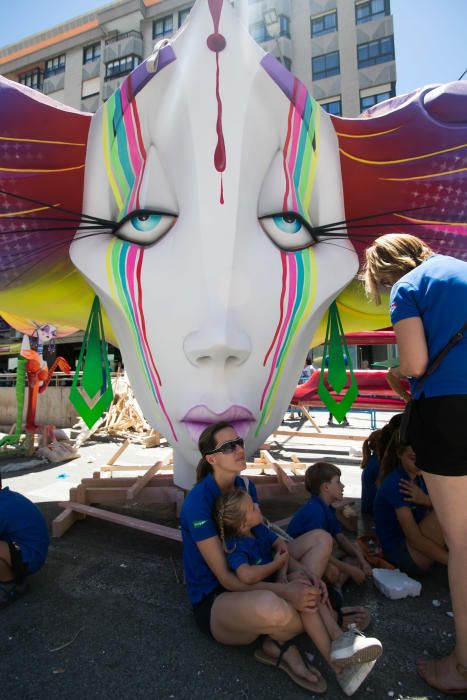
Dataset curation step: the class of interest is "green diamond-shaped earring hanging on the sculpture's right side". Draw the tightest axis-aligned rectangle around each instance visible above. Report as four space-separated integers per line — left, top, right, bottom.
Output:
318 301 358 423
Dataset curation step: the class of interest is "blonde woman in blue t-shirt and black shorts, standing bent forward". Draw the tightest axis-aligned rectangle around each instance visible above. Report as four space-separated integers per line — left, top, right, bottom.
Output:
364 233 467 696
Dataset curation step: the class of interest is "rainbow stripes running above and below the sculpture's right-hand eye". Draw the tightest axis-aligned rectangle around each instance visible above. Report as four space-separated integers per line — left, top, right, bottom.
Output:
256 59 320 435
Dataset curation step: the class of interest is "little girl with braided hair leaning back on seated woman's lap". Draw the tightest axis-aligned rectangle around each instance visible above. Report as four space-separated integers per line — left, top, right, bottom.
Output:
214 489 382 695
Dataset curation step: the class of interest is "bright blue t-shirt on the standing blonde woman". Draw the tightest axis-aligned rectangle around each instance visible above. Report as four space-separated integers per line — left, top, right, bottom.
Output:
390 255 467 398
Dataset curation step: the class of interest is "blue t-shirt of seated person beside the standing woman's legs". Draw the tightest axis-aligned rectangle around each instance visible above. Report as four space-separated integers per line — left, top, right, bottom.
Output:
373 466 428 559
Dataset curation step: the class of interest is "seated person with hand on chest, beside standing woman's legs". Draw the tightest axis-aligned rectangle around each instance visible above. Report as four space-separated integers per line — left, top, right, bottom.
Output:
374 431 448 578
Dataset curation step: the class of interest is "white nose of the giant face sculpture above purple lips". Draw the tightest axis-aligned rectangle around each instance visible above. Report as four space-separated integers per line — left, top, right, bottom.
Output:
183 319 251 367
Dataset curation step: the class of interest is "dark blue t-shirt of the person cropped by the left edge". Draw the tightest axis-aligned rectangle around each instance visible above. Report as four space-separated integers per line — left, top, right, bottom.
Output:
0 486 49 574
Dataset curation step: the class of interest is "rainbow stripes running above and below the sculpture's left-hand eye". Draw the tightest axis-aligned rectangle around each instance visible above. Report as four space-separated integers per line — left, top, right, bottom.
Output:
102 72 177 440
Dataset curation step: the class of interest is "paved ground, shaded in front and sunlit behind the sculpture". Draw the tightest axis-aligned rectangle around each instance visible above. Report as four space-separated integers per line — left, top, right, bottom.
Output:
0 414 453 700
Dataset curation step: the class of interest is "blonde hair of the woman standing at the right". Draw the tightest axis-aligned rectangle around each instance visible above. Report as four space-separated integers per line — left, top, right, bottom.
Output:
361 233 433 304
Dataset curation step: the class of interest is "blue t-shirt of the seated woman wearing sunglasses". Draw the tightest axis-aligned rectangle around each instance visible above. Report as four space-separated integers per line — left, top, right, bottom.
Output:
180 474 258 604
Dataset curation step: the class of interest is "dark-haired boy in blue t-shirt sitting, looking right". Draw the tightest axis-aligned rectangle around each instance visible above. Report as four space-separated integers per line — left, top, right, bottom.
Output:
287 462 372 592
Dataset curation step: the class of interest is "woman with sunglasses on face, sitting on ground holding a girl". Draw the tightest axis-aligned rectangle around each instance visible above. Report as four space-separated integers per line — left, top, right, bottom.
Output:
181 422 380 692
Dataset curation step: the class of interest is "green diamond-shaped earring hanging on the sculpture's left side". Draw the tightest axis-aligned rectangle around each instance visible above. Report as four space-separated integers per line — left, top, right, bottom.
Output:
70 296 113 428
